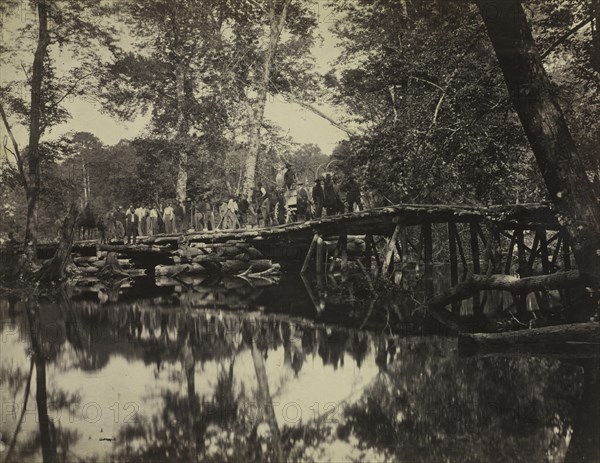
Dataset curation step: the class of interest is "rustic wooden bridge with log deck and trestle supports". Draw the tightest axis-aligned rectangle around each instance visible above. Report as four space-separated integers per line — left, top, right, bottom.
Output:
32 199 571 284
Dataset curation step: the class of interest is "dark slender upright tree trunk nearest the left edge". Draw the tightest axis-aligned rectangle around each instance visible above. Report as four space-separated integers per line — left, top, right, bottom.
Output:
25 0 50 256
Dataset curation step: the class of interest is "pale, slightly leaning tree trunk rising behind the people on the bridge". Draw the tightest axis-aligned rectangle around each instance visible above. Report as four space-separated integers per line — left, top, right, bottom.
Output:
244 0 291 200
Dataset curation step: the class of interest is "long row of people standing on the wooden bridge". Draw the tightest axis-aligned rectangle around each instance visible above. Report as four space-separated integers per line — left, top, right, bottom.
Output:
78 169 362 244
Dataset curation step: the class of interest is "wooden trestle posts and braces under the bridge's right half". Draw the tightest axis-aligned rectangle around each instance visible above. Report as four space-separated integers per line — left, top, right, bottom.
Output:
301 221 571 312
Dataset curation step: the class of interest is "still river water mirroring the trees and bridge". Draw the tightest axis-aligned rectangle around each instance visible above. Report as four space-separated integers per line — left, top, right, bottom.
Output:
0 272 600 463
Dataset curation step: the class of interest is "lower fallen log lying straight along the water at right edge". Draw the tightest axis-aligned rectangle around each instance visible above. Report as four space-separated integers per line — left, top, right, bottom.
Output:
458 322 600 351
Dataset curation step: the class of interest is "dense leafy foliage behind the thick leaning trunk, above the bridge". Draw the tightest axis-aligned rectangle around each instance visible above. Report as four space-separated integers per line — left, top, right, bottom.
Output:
326 0 598 204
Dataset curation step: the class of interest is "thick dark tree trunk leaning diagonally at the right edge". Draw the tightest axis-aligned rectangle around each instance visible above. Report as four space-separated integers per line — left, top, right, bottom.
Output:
477 0 600 278
